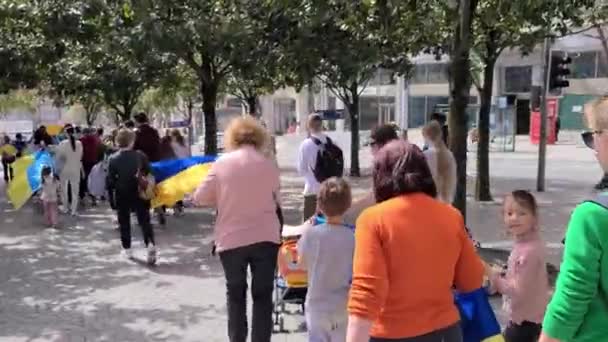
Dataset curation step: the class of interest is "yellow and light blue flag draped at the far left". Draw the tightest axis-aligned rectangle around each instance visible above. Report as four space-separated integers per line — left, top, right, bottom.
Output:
6 150 54 209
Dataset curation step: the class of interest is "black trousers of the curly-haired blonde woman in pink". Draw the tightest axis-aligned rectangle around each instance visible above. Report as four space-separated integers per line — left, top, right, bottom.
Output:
220 242 279 342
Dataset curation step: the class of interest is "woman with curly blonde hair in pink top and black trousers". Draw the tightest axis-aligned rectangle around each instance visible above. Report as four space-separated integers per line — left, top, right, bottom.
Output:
192 117 280 342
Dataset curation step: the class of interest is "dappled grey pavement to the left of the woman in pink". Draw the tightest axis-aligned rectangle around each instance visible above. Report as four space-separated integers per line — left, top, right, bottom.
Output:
0 198 225 341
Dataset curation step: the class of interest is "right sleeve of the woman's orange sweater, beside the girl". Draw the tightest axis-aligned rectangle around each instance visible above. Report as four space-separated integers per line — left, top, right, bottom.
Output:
454 214 485 292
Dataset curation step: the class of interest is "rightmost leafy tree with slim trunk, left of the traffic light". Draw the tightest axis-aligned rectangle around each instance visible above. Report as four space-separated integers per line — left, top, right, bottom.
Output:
473 0 594 201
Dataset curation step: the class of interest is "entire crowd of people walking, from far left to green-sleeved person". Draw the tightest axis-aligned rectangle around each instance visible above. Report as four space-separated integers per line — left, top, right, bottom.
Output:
2 99 608 342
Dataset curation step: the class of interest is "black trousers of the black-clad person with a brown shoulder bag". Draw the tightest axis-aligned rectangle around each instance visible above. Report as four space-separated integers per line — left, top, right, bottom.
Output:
116 193 155 249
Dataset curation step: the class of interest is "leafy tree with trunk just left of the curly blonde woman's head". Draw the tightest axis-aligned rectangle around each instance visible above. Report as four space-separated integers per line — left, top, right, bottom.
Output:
132 0 280 154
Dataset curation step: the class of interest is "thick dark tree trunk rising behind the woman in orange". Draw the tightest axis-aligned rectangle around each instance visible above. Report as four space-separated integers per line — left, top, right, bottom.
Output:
448 0 477 222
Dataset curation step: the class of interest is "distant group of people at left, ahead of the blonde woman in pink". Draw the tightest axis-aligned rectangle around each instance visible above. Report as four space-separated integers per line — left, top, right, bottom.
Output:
0 113 190 263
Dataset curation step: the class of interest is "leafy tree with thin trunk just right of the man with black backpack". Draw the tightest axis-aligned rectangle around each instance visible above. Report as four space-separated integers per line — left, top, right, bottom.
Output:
280 0 432 176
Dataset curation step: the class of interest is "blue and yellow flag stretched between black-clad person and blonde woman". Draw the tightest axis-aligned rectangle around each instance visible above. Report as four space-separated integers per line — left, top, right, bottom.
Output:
152 156 217 208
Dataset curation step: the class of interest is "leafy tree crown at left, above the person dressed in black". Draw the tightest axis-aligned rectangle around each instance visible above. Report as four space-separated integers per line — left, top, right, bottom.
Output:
48 0 175 122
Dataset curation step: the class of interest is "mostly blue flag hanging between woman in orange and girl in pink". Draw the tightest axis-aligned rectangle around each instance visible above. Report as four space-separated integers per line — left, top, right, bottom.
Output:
455 288 505 342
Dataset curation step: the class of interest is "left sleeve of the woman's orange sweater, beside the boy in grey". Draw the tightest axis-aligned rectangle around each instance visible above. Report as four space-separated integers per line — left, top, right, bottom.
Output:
348 213 388 321
